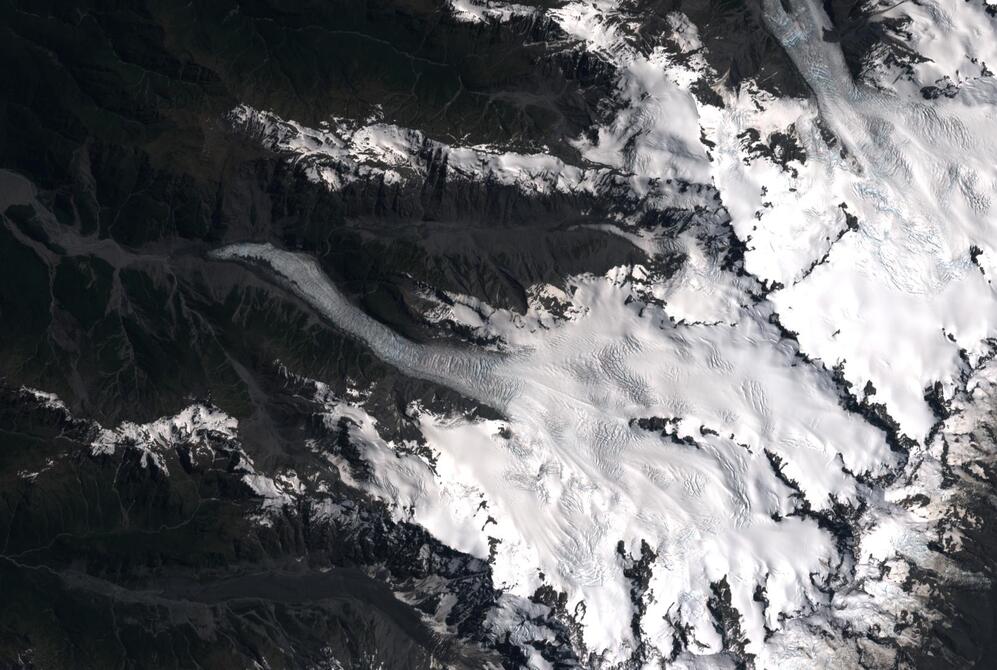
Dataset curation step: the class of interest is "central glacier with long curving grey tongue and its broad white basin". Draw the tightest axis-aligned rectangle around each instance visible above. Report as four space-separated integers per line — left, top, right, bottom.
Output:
212 239 896 661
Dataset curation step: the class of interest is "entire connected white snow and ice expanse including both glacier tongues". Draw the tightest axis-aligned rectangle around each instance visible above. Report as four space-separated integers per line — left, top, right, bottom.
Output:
206 0 997 668
